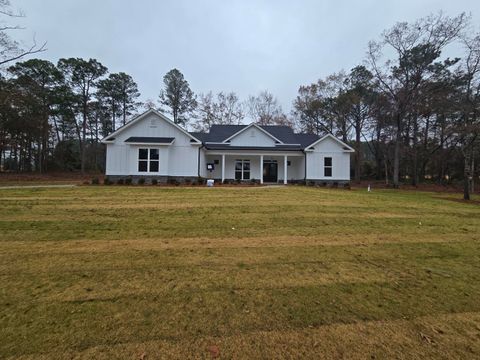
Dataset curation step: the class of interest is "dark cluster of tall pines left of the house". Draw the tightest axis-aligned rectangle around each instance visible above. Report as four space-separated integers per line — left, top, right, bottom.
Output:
0 58 140 173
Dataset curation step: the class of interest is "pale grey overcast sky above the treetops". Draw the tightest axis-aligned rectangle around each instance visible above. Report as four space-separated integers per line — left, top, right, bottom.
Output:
11 0 480 111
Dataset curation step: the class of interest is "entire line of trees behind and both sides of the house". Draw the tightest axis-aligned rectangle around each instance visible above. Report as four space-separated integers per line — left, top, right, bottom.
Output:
0 3 480 199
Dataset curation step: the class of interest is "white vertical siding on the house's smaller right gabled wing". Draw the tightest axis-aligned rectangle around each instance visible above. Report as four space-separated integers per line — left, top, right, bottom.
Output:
306 138 350 181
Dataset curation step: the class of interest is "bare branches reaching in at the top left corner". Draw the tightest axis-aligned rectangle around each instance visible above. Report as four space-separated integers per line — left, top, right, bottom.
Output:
0 0 46 66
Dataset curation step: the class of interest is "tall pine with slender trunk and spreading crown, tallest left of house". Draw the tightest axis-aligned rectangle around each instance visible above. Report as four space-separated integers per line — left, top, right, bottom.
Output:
58 58 107 174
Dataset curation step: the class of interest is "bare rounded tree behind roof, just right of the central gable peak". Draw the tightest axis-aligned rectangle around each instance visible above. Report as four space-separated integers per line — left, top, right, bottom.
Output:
247 90 286 125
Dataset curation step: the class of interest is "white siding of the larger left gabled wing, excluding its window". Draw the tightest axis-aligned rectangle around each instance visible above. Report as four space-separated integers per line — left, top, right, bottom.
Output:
106 113 199 176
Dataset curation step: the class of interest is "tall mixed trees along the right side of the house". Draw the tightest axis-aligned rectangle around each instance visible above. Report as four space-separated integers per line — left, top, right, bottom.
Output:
288 13 480 199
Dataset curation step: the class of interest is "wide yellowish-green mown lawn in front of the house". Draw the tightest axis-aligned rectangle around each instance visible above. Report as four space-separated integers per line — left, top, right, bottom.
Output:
0 186 480 359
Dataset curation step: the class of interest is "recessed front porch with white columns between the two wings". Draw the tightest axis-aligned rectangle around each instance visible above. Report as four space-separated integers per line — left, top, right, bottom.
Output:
206 152 305 184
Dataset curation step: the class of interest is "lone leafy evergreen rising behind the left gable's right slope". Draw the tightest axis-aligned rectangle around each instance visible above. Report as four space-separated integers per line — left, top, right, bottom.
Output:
160 69 197 125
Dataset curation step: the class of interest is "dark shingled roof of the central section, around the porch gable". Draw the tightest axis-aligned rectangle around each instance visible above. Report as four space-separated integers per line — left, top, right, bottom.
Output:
190 125 320 151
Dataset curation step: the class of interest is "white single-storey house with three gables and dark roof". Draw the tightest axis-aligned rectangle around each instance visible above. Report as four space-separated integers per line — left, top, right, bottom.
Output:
102 110 354 184
